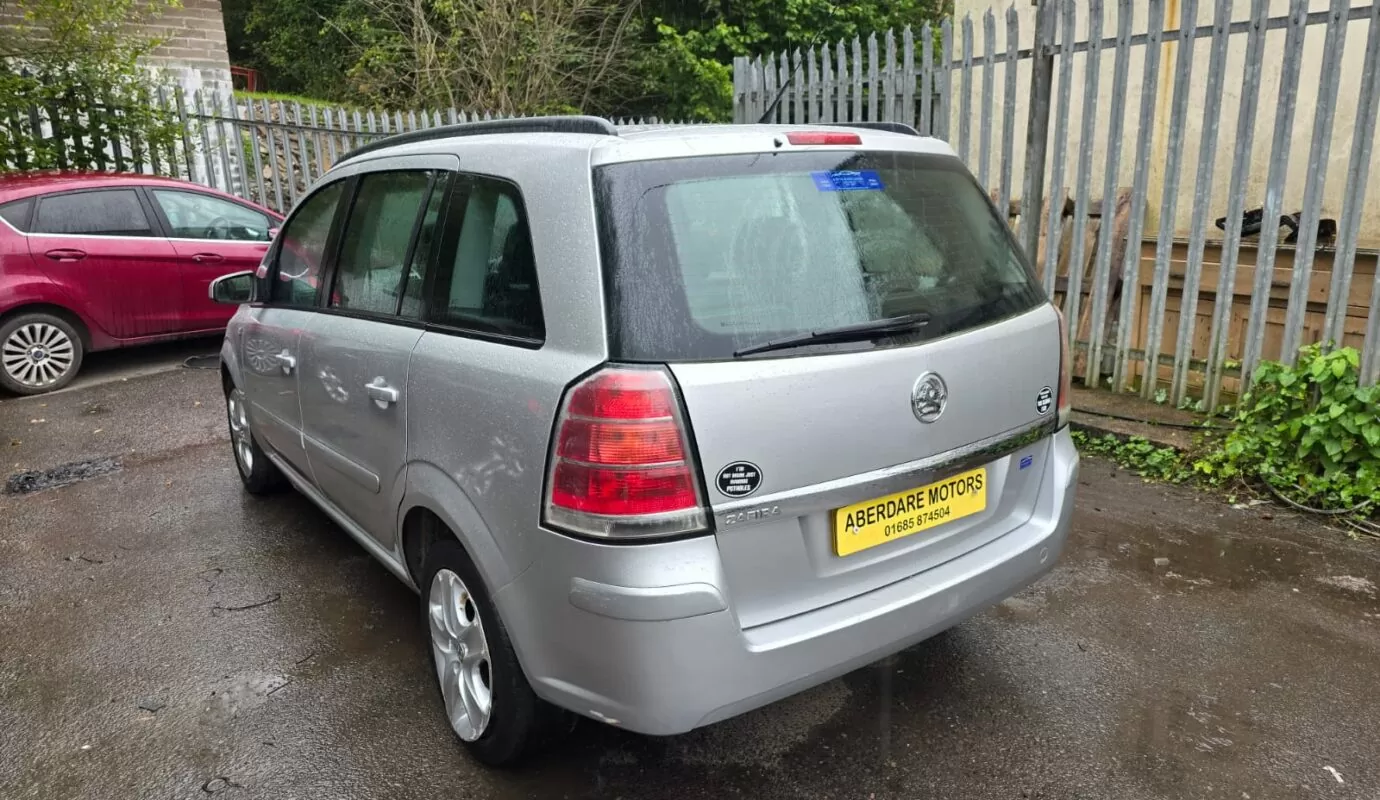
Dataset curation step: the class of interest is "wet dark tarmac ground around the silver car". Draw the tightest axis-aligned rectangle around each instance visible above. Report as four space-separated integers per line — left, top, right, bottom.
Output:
0 371 1380 800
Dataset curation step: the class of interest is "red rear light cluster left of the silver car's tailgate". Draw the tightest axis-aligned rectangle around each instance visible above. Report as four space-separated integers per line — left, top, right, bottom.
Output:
544 367 708 538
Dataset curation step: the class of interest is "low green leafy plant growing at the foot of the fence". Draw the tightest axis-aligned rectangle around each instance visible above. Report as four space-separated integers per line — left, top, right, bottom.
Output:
1194 345 1380 509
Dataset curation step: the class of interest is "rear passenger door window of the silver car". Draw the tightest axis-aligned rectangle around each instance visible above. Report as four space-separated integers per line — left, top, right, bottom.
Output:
330 171 432 314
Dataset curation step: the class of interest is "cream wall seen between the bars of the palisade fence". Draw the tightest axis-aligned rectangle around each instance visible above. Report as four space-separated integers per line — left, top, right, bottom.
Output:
951 0 1380 247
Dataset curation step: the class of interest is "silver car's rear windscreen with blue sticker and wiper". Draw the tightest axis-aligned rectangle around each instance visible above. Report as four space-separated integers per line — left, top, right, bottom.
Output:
595 150 1045 361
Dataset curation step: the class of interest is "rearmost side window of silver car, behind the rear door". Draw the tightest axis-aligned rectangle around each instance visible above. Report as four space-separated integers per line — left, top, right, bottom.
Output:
428 177 546 341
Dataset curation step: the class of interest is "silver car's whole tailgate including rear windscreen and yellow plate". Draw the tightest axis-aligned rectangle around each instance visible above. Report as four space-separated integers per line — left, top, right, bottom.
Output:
595 139 1060 626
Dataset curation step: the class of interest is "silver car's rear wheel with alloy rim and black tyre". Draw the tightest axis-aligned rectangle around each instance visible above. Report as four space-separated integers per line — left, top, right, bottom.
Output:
421 539 570 767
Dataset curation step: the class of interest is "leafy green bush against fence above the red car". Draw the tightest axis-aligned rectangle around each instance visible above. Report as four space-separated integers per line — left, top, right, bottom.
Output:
0 0 181 170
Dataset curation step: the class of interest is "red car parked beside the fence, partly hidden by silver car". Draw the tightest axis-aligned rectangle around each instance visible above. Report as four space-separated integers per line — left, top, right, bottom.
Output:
0 172 283 394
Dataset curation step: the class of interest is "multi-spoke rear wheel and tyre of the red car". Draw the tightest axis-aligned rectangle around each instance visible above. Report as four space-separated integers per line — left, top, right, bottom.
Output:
0 312 84 394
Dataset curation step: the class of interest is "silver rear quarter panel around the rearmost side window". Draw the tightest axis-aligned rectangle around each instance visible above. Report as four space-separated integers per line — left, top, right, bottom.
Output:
400 135 607 594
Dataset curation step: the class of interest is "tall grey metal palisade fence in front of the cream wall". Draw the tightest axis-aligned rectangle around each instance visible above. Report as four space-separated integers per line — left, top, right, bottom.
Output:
733 0 1380 397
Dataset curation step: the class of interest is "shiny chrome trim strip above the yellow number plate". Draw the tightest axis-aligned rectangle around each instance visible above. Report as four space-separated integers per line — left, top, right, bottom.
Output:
713 417 1058 532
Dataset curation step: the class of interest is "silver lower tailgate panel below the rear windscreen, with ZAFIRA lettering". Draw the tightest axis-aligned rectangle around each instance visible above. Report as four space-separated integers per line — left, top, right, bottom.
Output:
672 306 1060 628
